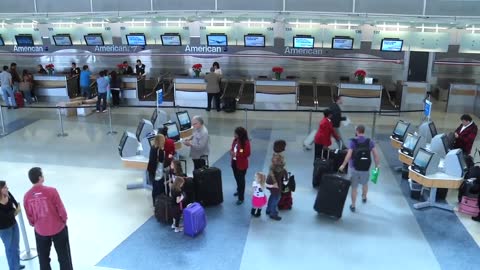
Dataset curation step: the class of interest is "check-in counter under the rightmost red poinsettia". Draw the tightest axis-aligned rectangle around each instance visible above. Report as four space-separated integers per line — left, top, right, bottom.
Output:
338 83 383 111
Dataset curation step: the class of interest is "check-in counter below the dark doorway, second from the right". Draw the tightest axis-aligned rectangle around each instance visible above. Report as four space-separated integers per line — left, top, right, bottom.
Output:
401 82 429 111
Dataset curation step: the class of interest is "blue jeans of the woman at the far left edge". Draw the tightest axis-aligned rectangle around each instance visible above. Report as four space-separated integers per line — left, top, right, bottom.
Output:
0 223 20 270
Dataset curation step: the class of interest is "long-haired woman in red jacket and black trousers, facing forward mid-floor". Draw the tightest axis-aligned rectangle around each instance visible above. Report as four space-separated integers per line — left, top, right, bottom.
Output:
230 127 250 205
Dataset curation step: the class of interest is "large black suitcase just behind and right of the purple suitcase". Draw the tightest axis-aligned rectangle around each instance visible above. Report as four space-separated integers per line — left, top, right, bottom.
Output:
193 167 223 206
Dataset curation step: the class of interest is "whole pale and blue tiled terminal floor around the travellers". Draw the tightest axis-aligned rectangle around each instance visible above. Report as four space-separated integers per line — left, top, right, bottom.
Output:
0 102 480 270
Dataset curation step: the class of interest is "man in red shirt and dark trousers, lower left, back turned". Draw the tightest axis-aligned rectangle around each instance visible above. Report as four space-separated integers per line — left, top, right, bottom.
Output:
23 167 73 270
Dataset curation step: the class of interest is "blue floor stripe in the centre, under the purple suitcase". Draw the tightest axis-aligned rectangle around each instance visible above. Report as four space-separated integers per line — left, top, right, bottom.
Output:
98 129 271 270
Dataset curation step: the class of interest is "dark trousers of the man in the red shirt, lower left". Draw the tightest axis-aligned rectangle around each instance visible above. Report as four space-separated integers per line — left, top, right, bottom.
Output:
35 226 73 270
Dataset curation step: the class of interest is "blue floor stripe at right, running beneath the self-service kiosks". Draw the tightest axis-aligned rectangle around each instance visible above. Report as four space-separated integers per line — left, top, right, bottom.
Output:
377 136 480 270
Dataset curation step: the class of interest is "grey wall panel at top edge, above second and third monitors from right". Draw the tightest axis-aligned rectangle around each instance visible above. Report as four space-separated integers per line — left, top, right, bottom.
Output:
279 0 353 12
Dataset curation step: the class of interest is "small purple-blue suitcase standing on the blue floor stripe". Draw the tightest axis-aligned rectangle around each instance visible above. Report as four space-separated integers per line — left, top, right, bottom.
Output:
183 203 207 237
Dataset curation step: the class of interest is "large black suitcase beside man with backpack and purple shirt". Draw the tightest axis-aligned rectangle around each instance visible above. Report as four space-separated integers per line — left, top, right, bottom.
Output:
313 174 350 218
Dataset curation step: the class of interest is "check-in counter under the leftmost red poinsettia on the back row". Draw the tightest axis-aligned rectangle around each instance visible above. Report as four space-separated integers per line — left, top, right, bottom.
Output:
173 78 207 108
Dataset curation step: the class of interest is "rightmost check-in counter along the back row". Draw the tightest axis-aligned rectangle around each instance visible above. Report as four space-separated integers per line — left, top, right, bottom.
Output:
447 83 478 113
